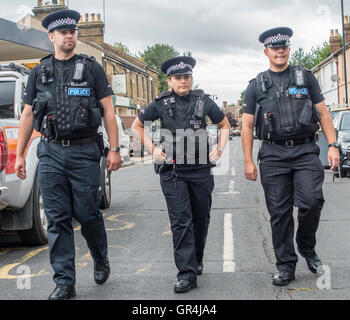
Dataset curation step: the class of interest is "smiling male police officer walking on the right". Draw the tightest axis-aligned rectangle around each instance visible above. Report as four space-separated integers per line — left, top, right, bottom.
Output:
242 28 339 286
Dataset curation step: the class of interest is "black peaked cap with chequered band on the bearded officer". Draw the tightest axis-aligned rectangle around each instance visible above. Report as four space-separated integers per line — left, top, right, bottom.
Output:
42 10 80 32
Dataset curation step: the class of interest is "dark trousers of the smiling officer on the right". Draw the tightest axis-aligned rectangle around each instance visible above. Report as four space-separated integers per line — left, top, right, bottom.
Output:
258 143 324 272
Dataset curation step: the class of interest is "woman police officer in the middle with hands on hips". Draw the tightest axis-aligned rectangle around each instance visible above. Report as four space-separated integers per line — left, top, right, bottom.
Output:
132 56 230 293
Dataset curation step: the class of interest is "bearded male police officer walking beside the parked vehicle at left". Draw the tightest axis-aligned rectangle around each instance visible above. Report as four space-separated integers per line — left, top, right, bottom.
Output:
16 10 121 300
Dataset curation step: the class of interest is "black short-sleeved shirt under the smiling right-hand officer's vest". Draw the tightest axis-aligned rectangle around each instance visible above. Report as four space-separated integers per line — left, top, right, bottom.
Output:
243 66 324 115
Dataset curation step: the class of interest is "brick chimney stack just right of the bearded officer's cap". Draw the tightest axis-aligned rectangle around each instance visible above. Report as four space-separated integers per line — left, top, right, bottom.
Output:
78 13 105 44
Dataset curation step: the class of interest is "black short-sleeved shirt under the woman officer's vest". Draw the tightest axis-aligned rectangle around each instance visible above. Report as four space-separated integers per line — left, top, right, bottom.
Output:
139 92 225 124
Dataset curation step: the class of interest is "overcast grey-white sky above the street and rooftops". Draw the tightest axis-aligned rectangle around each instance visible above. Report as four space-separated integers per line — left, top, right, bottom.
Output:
0 0 350 104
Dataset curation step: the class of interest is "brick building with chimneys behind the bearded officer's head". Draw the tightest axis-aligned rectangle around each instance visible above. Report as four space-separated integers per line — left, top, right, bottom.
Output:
19 0 159 115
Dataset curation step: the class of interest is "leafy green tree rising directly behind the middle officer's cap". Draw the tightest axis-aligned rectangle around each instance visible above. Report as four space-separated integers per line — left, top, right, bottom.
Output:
139 43 180 92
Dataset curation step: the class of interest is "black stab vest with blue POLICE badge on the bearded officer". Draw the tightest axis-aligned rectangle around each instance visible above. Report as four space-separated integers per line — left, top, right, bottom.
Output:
33 54 103 139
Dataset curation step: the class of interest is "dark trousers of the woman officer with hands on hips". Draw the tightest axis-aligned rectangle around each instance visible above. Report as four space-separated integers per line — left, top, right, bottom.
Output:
160 167 214 280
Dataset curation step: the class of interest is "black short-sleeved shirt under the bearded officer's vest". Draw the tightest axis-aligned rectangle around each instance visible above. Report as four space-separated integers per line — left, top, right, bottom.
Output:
23 56 114 106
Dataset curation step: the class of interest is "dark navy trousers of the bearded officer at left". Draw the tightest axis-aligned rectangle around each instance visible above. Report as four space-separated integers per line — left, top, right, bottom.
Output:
37 141 107 285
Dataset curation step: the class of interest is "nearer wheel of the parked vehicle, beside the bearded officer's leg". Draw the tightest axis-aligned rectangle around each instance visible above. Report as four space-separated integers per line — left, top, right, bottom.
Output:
18 174 47 245
